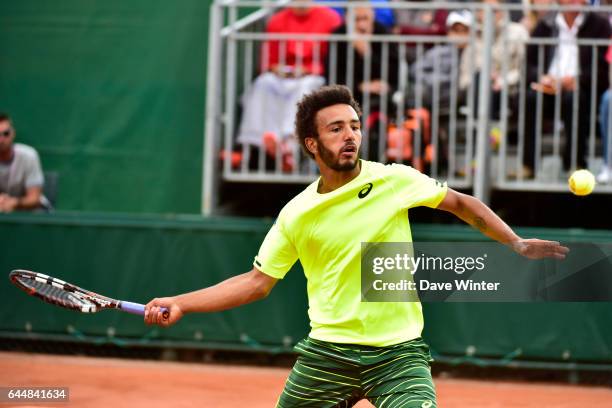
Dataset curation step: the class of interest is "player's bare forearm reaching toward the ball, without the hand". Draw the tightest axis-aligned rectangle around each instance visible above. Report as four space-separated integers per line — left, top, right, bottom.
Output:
454 194 520 244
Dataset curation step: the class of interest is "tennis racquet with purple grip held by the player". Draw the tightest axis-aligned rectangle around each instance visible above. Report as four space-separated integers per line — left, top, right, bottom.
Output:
9 269 170 319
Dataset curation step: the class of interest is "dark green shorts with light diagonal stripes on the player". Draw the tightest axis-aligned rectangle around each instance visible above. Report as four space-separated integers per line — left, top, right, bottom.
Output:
276 338 436 408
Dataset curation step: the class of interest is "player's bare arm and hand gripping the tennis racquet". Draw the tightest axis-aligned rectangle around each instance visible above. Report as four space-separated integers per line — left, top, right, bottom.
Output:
144 268 278 327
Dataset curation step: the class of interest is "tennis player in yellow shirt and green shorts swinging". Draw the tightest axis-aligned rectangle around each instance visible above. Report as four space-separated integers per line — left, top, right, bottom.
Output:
145 86 568 408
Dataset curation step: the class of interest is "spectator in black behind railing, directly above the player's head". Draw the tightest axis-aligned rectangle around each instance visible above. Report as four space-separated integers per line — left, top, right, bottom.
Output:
325 1 399 160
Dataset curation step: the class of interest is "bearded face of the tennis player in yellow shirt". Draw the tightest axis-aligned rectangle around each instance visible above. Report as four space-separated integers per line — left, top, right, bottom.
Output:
317 104 361 171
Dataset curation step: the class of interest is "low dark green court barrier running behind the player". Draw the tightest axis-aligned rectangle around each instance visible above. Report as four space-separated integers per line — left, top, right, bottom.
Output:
0 214 612 369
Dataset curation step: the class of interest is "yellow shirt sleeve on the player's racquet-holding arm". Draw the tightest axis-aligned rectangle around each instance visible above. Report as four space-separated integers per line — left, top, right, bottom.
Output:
253 217 298 279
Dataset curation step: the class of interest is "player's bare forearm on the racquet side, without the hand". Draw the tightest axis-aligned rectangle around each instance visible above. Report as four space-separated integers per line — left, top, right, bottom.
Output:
175 272 271 313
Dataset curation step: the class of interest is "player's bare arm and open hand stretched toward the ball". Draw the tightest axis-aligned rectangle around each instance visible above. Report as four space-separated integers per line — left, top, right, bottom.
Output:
438 188 569 259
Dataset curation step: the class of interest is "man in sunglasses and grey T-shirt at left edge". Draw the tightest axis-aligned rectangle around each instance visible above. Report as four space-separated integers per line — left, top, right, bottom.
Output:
0 113 46 213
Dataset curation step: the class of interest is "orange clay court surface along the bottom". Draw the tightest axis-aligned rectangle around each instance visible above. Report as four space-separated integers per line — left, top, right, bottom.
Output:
0 352 612 408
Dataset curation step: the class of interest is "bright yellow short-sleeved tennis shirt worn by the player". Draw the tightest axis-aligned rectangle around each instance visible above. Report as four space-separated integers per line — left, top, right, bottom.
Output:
253 160 447 347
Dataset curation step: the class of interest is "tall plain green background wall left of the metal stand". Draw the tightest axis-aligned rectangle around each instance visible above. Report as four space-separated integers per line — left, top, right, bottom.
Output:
0 0 211 213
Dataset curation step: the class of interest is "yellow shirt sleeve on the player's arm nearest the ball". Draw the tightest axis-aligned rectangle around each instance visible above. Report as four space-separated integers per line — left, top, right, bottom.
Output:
391 164 448 209
